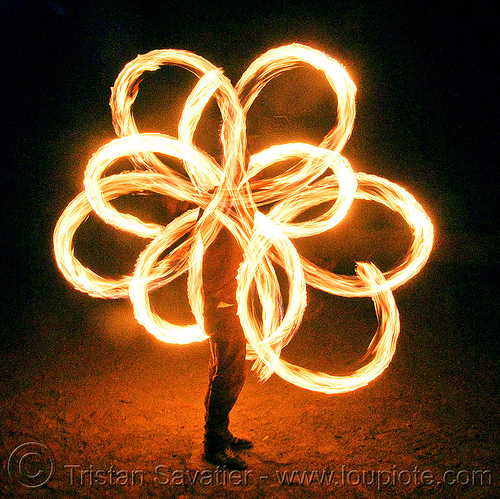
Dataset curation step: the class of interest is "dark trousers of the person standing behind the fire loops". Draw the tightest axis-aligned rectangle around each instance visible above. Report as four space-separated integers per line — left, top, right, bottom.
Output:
204 304 246 433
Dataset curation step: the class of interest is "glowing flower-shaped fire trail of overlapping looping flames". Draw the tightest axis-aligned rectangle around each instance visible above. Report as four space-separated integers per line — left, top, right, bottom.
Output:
54 44 433 393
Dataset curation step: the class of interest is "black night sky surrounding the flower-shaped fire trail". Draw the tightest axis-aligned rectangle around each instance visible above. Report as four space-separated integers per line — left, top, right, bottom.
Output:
0 0 500 496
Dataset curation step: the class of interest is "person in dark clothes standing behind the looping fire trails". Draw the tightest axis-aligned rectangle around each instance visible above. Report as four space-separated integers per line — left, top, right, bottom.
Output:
164 199 253 470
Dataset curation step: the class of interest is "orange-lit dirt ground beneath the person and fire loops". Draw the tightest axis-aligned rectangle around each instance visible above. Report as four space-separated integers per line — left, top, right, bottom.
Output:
0 254 500 498
